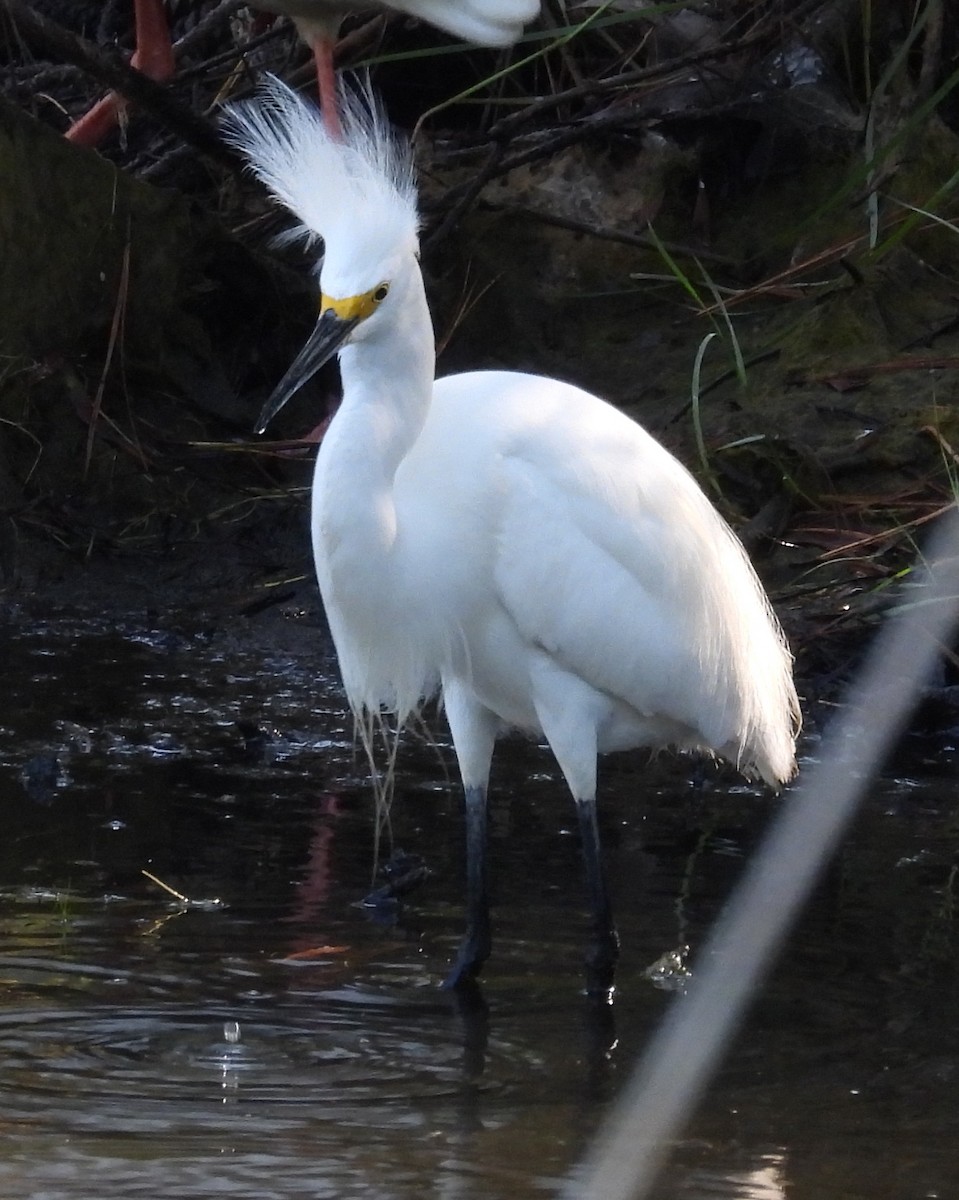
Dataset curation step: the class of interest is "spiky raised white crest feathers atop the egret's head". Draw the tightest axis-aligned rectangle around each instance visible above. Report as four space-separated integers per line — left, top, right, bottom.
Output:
223 77 419 260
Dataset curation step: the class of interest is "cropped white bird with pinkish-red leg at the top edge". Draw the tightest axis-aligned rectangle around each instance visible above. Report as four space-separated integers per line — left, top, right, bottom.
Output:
252 0 540 137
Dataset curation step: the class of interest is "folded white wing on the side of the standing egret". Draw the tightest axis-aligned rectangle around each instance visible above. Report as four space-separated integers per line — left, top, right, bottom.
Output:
495 381 768 746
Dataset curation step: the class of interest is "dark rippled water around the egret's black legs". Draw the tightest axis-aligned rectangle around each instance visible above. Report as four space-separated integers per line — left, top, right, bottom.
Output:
0 614 959 1200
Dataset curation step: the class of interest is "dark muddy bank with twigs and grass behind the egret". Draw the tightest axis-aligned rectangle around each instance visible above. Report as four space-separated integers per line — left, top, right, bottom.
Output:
0 2 959 700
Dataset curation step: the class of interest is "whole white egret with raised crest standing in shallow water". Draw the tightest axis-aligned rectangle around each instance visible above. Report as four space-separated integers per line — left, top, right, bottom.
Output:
228 82 799 994
